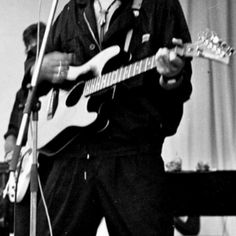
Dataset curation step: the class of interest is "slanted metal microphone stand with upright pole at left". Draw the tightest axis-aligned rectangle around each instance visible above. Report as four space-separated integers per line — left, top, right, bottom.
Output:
9 0 58 236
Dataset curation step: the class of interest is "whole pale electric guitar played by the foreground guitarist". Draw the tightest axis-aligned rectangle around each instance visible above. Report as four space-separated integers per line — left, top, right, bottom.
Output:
38 32 234 156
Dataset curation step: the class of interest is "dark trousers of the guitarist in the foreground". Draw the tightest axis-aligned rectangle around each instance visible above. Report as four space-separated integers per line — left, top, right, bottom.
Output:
37 143 173 236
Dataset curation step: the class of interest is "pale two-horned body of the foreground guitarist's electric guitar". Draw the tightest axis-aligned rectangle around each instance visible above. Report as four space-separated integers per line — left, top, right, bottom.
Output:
38 46 120 156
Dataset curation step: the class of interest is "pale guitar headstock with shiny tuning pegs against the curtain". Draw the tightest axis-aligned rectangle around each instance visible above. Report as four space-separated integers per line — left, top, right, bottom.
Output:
177 31 234 64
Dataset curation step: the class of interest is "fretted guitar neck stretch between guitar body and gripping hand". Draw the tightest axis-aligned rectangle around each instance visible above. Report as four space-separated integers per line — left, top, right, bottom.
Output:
84 55 156 96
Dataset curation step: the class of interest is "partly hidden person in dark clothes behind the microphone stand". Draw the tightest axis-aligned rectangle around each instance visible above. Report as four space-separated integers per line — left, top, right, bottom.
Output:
4 22 46 236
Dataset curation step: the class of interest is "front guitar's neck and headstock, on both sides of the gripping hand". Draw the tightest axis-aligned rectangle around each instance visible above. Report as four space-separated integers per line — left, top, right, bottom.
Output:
84 38 230 96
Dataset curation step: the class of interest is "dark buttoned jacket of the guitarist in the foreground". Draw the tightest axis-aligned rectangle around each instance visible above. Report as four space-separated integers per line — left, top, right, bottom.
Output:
24 0 192 153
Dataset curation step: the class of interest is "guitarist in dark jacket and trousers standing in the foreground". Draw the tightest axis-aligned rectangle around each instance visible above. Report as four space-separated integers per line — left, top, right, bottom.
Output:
25 0 192 236
